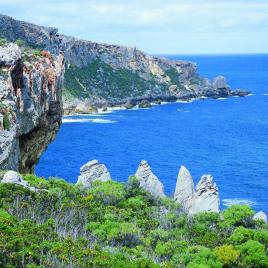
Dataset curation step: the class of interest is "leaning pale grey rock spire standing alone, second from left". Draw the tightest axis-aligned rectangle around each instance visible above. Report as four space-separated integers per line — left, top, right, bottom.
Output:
135 160 165 197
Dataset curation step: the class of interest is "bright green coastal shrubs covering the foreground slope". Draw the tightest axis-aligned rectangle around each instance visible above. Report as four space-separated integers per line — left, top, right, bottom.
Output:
0 175 268 268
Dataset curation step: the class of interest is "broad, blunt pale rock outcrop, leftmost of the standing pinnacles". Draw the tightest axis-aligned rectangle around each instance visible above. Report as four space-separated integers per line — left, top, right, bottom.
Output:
77 160 111 188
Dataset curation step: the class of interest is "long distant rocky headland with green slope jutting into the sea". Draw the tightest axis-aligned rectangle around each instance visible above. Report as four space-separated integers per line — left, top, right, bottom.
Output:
0 15 246 112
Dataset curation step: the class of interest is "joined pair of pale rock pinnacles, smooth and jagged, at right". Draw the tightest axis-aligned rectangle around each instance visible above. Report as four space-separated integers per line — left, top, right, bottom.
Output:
174 166 220 214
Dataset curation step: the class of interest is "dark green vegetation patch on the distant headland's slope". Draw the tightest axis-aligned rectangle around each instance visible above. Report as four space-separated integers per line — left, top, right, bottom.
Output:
64 59 164 100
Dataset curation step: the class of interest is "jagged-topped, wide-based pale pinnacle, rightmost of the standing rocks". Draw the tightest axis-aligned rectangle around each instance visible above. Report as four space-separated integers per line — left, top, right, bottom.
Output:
189 175 219 214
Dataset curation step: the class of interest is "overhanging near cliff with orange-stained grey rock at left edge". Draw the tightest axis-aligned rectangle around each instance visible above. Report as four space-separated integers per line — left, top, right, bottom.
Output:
0 42 64 172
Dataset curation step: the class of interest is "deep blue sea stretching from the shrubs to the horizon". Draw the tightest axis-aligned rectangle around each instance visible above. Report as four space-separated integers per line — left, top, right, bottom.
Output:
35 55 268 213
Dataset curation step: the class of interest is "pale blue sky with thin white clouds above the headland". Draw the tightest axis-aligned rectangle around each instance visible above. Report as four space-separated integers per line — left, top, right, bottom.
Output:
0 0 268 54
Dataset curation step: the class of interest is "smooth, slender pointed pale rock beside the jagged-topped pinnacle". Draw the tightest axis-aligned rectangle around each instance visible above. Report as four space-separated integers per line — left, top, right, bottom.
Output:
174 166 194 211
